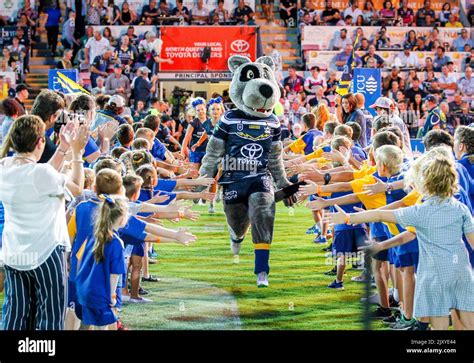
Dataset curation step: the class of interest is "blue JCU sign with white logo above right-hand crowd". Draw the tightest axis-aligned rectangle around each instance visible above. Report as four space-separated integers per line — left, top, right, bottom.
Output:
352 68 382 116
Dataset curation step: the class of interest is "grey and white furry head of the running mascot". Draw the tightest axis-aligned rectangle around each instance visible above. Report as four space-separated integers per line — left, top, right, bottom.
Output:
228 55 280 118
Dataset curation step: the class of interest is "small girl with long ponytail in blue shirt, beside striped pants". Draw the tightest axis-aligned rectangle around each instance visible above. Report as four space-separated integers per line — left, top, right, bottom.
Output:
75 196 128 330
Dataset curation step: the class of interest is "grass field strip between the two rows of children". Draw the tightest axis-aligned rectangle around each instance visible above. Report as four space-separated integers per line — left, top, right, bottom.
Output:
0 203 382 330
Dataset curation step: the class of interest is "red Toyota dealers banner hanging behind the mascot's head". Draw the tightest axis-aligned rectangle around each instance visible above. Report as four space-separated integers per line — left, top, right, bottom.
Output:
160 26 257 72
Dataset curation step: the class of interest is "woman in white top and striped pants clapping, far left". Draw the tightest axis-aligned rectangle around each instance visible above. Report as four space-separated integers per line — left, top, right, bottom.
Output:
0 115 89 330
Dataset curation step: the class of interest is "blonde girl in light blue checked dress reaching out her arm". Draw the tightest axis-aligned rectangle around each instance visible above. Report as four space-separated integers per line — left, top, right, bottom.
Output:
328 148 474 330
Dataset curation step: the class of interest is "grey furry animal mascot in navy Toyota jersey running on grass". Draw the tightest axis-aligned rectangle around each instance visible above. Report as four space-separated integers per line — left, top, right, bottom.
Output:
200 56 295 287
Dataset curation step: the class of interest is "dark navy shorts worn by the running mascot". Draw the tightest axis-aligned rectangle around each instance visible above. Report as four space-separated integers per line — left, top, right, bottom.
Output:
222 174 275 204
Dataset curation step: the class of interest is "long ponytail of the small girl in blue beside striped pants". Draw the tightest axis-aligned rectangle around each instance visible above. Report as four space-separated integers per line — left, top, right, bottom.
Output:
92 194 128 263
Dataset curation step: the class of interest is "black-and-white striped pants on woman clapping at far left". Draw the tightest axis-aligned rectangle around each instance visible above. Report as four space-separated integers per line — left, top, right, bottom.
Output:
2 246 67 330
